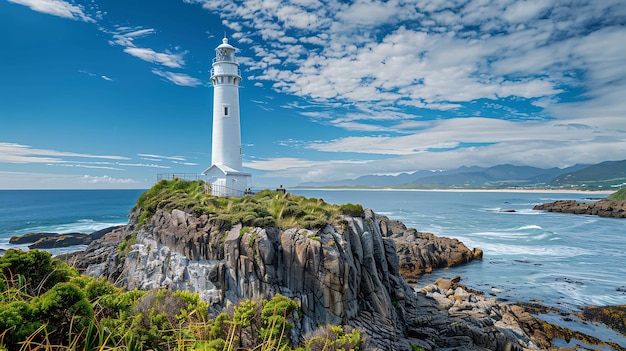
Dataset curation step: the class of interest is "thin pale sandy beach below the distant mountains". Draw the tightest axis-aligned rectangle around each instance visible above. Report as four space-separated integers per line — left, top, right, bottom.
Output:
287 187 619 195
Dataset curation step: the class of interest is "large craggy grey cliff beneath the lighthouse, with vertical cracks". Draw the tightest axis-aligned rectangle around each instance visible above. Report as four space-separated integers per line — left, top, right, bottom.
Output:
64 205 556 350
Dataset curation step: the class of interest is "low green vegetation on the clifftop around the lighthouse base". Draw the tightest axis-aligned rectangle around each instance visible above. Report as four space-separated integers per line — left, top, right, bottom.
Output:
136 179 363 229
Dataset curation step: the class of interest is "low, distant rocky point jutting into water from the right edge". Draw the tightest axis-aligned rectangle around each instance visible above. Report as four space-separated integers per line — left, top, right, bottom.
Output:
533 200 626 218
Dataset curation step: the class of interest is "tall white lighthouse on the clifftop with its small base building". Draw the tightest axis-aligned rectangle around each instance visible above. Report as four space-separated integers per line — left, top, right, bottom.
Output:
202 38 251 196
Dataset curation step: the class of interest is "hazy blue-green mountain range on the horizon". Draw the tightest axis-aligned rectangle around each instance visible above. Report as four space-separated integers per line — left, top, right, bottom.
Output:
298 160 626 190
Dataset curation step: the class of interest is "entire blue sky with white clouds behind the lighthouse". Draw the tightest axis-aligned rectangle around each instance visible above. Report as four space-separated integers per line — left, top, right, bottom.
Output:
0 0 626 189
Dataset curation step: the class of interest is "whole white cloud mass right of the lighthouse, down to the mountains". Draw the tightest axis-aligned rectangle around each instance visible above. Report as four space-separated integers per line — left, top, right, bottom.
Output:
185 0 626 184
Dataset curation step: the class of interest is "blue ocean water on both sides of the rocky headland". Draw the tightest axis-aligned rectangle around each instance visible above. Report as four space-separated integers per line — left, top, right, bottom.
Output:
0 190 626 347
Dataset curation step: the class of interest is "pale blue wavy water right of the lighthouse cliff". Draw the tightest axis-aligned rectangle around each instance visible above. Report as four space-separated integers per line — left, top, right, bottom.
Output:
293 190 626 309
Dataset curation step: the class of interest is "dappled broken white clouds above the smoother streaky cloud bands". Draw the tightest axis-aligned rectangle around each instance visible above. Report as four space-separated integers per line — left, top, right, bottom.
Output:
186 0 624 118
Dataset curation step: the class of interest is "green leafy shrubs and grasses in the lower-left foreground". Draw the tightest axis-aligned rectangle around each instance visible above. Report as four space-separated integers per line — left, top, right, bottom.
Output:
0 250 361 351
